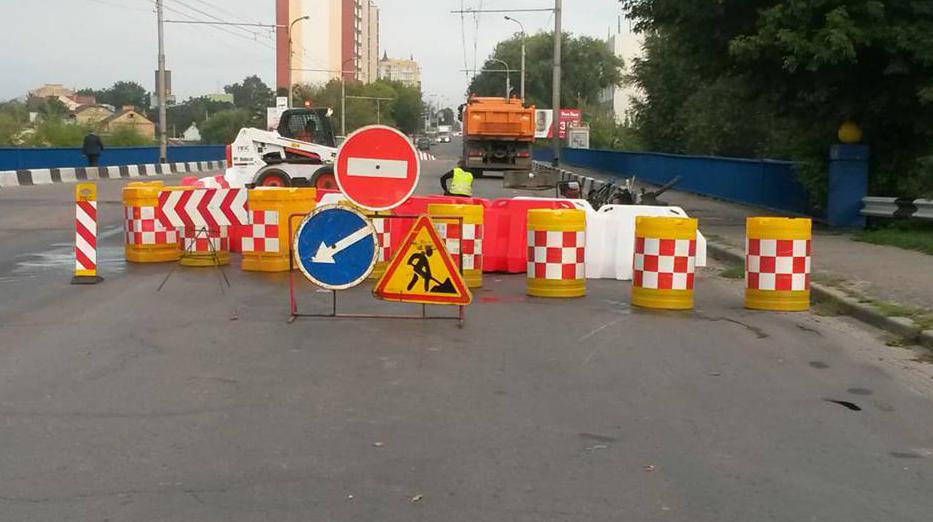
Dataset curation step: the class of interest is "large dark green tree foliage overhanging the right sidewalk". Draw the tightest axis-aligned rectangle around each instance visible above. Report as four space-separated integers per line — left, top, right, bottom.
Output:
623 0 933 196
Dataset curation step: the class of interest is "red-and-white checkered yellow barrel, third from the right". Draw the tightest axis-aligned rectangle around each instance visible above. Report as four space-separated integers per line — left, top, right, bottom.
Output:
525 209 586 297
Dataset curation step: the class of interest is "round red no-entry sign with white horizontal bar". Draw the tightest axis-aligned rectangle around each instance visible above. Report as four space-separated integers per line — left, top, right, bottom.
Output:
334 125 421 211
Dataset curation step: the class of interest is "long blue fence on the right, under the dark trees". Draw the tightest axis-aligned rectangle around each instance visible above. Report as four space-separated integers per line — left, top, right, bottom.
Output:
535 149 810 214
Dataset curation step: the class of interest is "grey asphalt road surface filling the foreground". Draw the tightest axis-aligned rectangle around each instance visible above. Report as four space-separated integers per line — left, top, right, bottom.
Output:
0 139 933 522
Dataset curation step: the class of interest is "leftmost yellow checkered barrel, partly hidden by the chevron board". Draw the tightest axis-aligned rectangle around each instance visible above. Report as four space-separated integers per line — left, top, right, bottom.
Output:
123 181 181 263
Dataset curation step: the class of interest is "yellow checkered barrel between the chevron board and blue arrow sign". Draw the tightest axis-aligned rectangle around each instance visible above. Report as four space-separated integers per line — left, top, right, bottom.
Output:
240 187 317 272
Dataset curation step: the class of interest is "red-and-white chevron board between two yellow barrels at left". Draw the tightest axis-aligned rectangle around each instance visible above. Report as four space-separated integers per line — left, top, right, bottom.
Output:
158 189 249 230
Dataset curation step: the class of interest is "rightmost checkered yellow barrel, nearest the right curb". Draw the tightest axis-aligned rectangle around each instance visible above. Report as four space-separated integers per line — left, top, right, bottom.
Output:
745 217 813 312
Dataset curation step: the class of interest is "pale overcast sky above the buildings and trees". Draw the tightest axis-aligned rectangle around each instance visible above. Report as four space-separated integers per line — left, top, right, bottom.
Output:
0 0 618 106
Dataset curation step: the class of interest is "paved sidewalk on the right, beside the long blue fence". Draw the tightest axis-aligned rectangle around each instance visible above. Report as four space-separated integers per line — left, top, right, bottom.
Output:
564 165 933 310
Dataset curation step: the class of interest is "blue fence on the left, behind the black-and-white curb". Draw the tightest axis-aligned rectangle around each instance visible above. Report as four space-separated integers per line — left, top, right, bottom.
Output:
0 145 226 171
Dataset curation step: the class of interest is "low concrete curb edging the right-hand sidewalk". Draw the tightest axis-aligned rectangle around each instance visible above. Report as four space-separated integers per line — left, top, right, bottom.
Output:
706 238 933 350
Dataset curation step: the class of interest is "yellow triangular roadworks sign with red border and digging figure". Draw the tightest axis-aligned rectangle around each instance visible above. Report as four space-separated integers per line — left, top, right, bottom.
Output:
373 216 473 305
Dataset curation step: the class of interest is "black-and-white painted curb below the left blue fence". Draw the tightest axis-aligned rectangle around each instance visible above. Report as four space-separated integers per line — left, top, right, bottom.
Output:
0 160 226 188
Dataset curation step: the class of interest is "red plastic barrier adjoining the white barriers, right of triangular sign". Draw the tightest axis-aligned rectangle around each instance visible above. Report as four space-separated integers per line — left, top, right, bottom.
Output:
483 199 572 274
